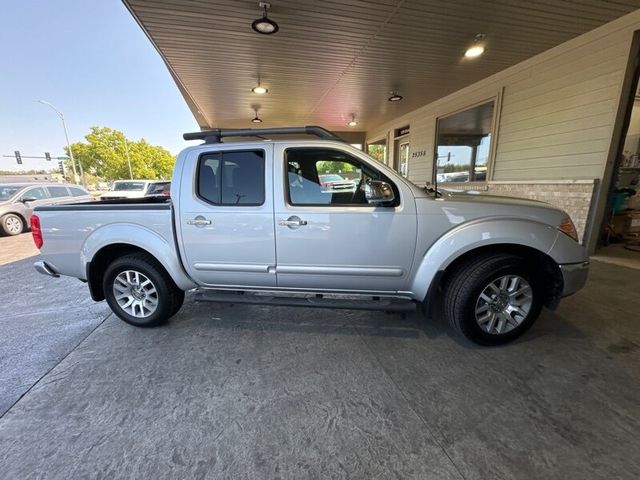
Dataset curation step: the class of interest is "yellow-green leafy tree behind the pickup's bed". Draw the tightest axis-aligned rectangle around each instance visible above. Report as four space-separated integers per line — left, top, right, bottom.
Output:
67 127 176 180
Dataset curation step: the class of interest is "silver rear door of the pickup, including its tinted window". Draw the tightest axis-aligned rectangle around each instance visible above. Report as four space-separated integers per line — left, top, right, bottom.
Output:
174 143 276 287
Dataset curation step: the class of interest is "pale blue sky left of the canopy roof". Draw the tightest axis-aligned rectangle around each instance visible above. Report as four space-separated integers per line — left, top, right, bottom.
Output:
0 0 199 170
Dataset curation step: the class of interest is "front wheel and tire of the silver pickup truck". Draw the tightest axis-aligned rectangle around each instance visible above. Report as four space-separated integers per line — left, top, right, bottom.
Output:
443 254 544 345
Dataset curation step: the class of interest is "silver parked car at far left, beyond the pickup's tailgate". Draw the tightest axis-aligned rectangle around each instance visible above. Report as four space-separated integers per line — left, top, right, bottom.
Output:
0 183 92 235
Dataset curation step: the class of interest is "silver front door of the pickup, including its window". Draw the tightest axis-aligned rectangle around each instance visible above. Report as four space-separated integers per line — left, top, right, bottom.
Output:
274 143 416 292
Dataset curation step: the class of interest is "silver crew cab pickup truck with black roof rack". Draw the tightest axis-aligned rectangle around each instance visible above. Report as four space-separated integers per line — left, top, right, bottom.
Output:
31 127 588 345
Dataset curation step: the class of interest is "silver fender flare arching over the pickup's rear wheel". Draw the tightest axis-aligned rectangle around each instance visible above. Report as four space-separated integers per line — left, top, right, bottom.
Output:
80 223 196 290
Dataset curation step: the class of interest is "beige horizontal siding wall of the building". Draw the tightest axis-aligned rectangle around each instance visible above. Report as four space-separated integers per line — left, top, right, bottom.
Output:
367 11 640 183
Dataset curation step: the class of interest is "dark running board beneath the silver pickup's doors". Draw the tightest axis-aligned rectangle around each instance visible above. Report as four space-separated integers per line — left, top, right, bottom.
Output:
195 290 417 312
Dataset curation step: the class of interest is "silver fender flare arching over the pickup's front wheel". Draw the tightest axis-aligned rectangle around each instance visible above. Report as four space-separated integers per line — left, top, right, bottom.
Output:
410 217 559 301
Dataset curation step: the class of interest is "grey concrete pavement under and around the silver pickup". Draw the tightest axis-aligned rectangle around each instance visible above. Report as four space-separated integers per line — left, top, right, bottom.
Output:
0 234 640 480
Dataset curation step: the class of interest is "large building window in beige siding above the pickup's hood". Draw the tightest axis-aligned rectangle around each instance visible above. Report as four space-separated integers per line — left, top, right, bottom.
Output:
436 100 495 183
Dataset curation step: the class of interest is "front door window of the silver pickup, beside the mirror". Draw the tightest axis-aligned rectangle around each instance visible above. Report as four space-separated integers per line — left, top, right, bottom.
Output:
285 148 389 205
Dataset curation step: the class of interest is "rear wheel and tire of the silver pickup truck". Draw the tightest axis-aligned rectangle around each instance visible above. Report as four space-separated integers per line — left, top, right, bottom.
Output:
102 253 184 327
